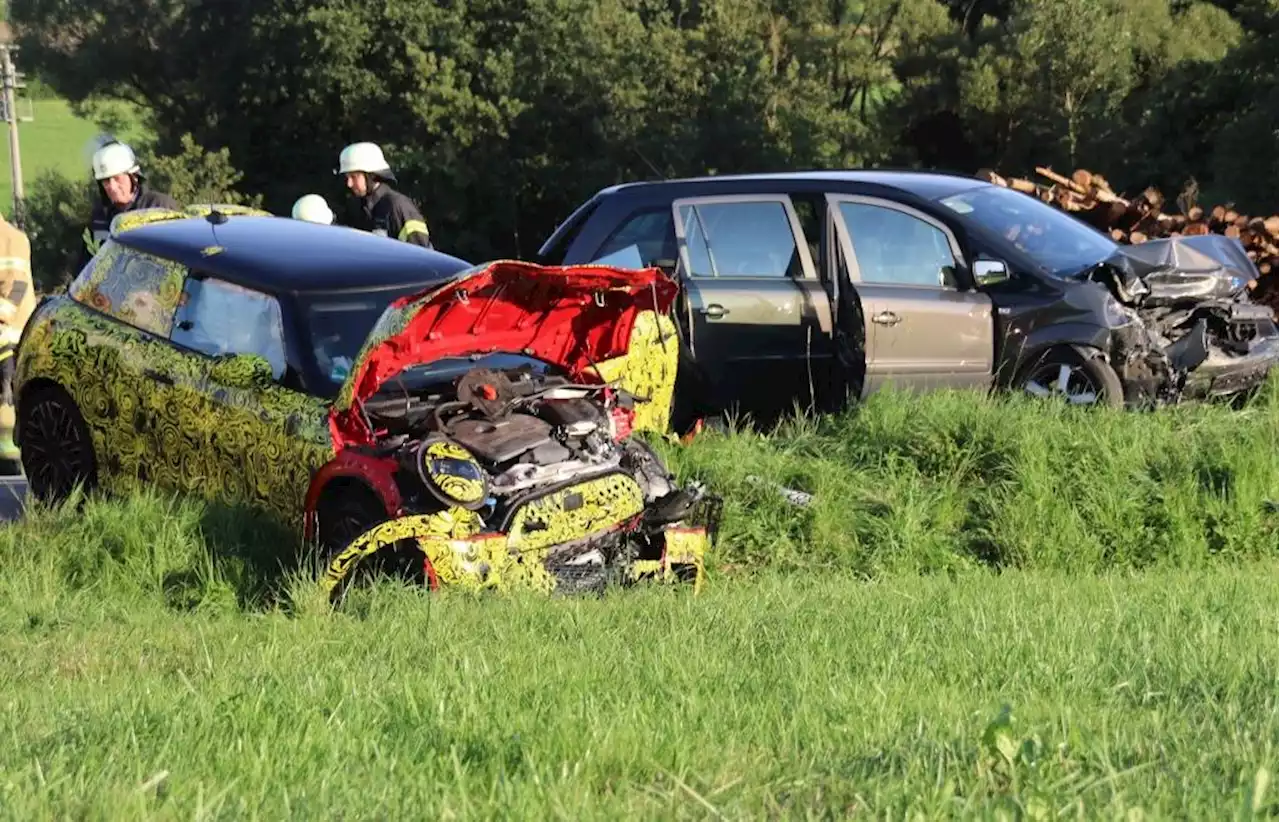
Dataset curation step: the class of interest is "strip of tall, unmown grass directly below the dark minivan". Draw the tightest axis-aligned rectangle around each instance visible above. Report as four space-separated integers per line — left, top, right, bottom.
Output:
664 382 1280 576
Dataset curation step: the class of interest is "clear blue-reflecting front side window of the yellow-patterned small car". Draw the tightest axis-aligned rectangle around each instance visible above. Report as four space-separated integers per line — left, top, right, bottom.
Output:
170 277 285 380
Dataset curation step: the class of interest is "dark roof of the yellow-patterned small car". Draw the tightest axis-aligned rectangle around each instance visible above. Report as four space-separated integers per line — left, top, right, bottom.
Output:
113 215 471 293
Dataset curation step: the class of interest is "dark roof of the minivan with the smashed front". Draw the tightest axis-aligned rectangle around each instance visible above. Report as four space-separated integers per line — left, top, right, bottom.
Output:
599 169 991 200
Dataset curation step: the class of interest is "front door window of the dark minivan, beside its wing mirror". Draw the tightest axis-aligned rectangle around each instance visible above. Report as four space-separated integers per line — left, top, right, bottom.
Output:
840 202 956 288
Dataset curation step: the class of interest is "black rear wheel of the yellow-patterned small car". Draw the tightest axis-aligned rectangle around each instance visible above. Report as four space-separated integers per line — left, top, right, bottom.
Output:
18 385 97 503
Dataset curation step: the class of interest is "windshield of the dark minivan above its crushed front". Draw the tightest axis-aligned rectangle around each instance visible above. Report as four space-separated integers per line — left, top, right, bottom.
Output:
941 186 1119 278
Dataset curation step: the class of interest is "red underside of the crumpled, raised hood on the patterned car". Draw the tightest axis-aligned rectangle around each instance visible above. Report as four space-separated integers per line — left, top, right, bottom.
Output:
329 260 678 449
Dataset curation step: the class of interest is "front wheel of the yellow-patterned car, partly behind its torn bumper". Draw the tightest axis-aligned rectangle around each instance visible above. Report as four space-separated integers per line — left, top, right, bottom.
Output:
316 481 426 604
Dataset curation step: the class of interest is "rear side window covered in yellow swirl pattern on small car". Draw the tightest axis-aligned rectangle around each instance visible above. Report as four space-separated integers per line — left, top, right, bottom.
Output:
68 239 186 337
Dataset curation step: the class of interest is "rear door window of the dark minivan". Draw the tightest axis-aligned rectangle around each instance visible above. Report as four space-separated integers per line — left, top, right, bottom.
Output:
680 200 804 278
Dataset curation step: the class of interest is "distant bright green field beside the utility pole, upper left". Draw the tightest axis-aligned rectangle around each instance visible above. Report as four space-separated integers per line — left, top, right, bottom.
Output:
0 100 99 216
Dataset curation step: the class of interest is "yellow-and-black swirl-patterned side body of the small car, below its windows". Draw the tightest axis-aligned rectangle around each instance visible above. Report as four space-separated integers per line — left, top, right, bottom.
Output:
14 297 334 526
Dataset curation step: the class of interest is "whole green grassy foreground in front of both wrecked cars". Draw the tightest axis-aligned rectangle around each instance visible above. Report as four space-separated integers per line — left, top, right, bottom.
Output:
0 387 1280 818
